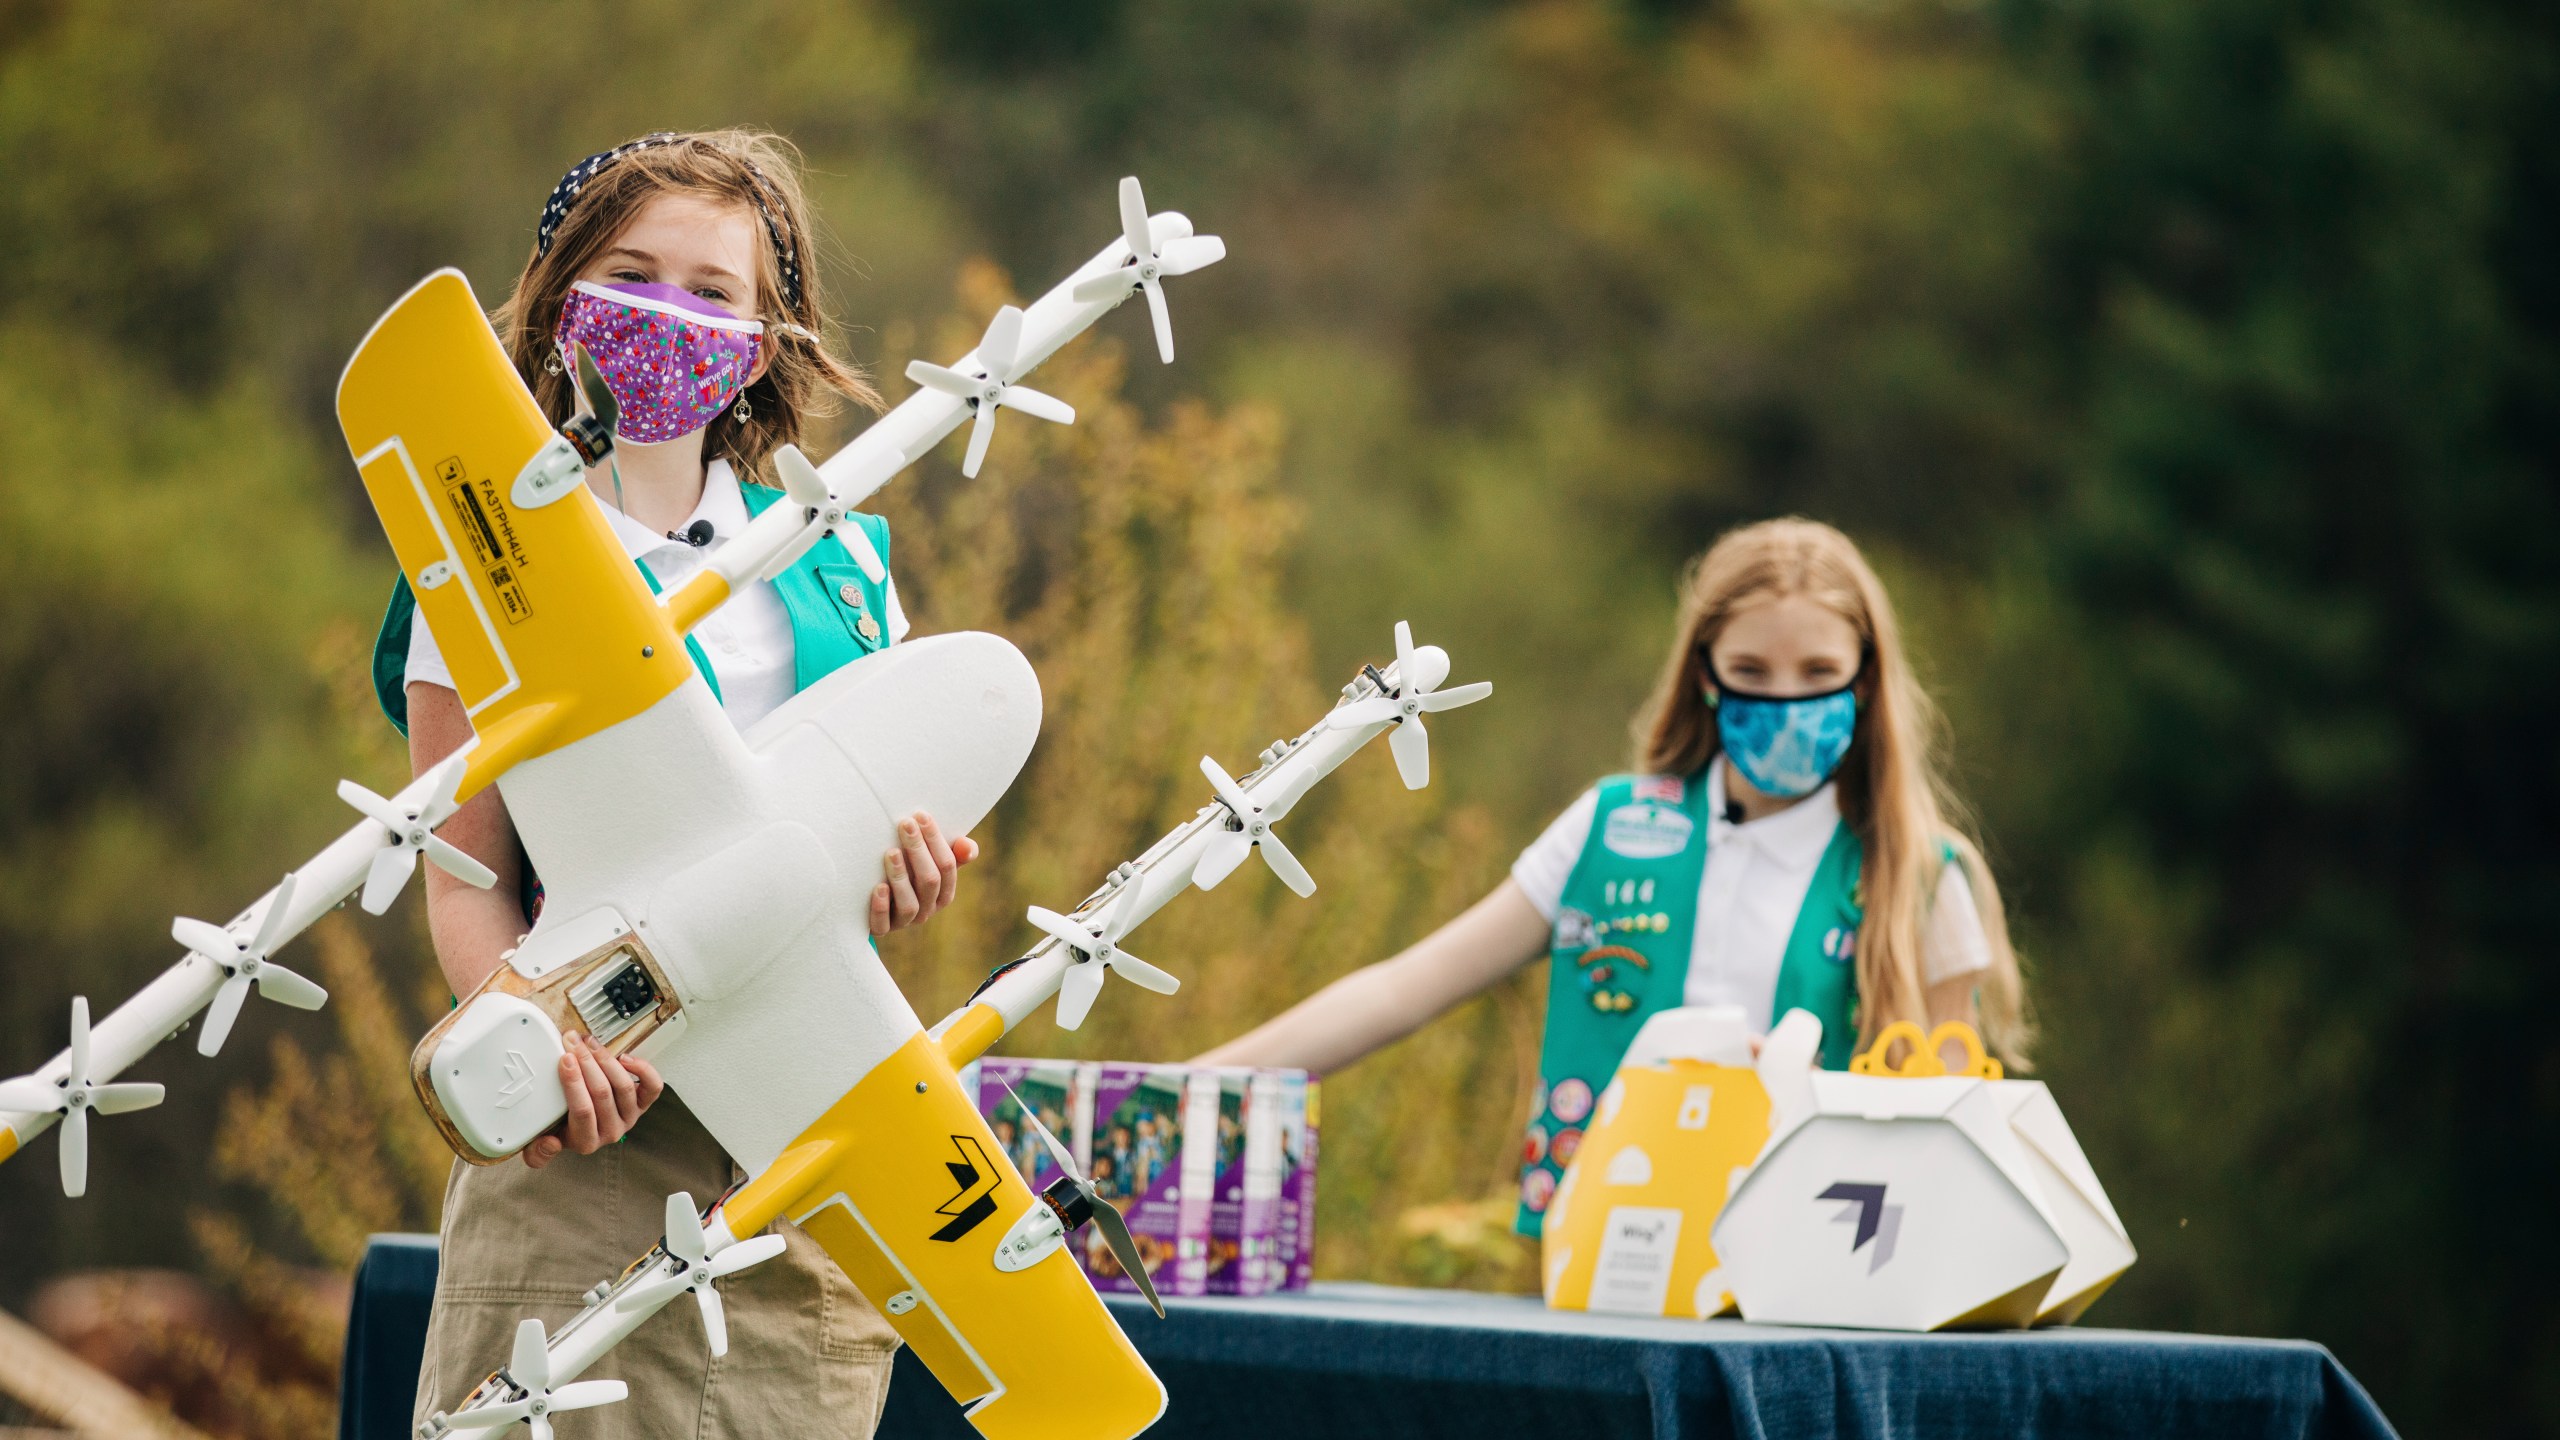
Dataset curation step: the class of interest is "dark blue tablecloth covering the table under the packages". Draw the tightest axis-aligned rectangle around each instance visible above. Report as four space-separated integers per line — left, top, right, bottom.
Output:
338 1235 2391 1440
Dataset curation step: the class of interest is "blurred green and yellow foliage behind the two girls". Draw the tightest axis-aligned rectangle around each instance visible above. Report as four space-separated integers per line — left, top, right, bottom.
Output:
0 0 2560 1435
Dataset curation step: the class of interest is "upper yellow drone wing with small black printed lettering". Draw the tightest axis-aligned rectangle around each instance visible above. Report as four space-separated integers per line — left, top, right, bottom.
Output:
338 269 691 794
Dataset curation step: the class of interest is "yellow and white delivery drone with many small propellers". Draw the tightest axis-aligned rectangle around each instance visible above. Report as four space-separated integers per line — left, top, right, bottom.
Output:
0 179 1492 1440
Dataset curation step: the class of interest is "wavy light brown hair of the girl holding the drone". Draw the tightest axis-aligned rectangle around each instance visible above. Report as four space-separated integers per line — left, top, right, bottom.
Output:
492 131 881 482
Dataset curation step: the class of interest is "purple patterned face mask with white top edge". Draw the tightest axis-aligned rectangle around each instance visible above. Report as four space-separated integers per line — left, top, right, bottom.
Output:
558 279 765 446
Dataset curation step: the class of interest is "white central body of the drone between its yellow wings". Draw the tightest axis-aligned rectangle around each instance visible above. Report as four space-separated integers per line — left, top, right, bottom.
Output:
455 635 1039 1174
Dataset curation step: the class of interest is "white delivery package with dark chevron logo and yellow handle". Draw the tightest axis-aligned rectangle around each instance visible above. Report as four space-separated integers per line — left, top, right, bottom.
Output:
1713 1012 2132 1330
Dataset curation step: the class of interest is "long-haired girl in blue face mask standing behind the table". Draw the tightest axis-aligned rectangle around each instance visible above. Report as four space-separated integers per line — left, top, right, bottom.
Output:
1201 520 2028 1235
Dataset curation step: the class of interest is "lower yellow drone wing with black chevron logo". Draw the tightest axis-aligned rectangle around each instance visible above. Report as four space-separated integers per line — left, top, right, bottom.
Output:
722 1033 1165 1440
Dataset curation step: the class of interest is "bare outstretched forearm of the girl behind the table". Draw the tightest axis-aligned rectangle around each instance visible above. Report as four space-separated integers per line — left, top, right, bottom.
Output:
1196 879 1546 1074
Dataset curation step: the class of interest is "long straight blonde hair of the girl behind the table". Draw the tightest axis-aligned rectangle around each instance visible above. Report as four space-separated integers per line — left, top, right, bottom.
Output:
1633 518 2030 1068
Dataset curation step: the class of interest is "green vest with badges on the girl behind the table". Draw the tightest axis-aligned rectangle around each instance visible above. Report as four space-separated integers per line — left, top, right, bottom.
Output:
1516 774 1864 1235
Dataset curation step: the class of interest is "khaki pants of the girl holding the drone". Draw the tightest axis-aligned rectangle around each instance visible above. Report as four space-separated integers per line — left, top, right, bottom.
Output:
412 1092 899 1440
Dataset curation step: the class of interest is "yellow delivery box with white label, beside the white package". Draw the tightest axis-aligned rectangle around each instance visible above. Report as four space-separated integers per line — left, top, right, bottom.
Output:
1541 1004 1769 1320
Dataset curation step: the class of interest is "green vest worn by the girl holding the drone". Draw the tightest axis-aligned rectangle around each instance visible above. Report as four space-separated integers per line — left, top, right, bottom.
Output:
374 484 888 735
